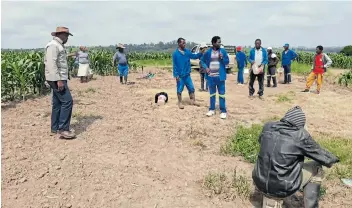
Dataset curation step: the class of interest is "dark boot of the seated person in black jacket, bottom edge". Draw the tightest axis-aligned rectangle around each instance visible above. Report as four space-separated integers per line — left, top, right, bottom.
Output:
303 183 320 208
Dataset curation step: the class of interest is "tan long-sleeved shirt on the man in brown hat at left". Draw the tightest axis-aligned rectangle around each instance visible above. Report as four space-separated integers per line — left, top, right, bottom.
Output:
44 37 68 81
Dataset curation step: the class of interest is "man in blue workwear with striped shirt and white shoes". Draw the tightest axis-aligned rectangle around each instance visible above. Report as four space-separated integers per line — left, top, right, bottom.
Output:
201 36 230 119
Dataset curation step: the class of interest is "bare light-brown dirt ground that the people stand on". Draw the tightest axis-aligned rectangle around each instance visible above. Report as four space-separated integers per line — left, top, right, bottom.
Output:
1 71 352 208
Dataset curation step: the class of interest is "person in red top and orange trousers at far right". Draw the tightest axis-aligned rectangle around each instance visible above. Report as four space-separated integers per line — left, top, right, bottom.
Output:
303 46 332 95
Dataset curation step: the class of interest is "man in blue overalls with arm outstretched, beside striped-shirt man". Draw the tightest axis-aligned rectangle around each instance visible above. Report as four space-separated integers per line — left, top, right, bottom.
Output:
172 38 203 109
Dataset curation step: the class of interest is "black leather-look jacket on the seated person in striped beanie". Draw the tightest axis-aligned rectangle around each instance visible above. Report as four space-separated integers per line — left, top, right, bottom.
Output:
252 117 339 198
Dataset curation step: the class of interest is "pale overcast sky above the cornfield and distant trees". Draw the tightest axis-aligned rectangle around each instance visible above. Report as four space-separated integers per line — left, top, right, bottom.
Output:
1 1 352 48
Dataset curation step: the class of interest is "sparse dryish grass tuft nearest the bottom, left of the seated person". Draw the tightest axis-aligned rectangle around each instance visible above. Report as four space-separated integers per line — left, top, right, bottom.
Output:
203 170 251 199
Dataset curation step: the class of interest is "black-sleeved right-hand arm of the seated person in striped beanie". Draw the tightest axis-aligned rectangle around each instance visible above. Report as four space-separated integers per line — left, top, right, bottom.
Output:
298 132 339 168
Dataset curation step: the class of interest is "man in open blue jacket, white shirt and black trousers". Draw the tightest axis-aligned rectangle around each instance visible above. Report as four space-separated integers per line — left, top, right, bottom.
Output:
248 39 268 99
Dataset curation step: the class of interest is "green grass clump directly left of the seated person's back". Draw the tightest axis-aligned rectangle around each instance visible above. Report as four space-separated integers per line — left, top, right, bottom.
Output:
221 124 263 163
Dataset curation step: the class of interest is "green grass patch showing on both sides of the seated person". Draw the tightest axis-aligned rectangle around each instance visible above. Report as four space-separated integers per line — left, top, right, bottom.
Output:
221 123 352 178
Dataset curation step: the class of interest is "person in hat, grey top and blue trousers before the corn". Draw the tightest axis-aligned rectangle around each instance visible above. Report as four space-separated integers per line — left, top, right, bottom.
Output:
112 43 128 84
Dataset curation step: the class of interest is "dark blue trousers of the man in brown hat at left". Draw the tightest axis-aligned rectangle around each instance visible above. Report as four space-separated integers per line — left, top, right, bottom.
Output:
48 81 73 132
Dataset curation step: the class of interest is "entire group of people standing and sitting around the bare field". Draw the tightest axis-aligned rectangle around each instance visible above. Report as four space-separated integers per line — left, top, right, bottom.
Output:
44 27 339 208
